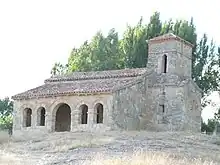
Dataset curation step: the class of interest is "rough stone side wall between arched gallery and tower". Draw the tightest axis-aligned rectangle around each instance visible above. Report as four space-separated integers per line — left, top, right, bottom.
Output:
112 78 147 130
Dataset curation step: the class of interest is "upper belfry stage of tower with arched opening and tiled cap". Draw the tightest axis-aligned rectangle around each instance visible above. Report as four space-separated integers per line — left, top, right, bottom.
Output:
147 33 193 77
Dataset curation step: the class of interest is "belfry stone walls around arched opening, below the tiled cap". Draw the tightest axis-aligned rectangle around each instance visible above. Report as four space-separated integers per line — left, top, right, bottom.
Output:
147 40 192 77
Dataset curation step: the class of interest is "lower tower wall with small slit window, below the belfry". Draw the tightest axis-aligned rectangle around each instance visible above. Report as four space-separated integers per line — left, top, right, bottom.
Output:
147 82 185 131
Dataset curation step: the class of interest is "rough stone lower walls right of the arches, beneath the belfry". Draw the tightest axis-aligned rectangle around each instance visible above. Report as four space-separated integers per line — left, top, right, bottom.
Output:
112 74 201 131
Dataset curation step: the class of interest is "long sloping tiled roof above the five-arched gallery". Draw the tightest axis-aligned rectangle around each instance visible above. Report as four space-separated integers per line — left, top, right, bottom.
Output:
12 68 146 100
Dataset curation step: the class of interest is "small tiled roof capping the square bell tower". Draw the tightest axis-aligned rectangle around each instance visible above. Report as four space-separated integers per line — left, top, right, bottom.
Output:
149 33 194 47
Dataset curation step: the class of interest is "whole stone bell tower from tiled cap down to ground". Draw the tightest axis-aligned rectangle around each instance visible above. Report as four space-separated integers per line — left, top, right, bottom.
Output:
147 33 201 131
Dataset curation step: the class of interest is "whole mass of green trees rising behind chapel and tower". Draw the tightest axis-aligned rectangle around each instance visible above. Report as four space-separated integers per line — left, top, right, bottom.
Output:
51 12 220 106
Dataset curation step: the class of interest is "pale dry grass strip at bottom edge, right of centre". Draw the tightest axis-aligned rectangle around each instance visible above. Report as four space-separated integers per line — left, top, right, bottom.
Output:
88 152 217 165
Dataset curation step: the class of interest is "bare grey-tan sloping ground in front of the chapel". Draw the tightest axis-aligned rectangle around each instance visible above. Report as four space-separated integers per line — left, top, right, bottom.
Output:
0 131 220 165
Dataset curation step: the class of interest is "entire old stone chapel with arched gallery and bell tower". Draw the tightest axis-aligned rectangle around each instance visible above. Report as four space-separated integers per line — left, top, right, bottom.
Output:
12 33 201 136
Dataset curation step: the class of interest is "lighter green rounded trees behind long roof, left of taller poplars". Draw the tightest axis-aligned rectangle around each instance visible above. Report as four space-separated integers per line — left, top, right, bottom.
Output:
68 29 122 72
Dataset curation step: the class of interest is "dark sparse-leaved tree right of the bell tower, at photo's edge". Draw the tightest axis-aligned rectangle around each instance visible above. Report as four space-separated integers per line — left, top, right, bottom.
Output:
192 34 220 97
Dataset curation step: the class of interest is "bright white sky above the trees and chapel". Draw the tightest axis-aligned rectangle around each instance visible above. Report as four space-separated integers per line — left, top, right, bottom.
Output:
0 0 220 121
